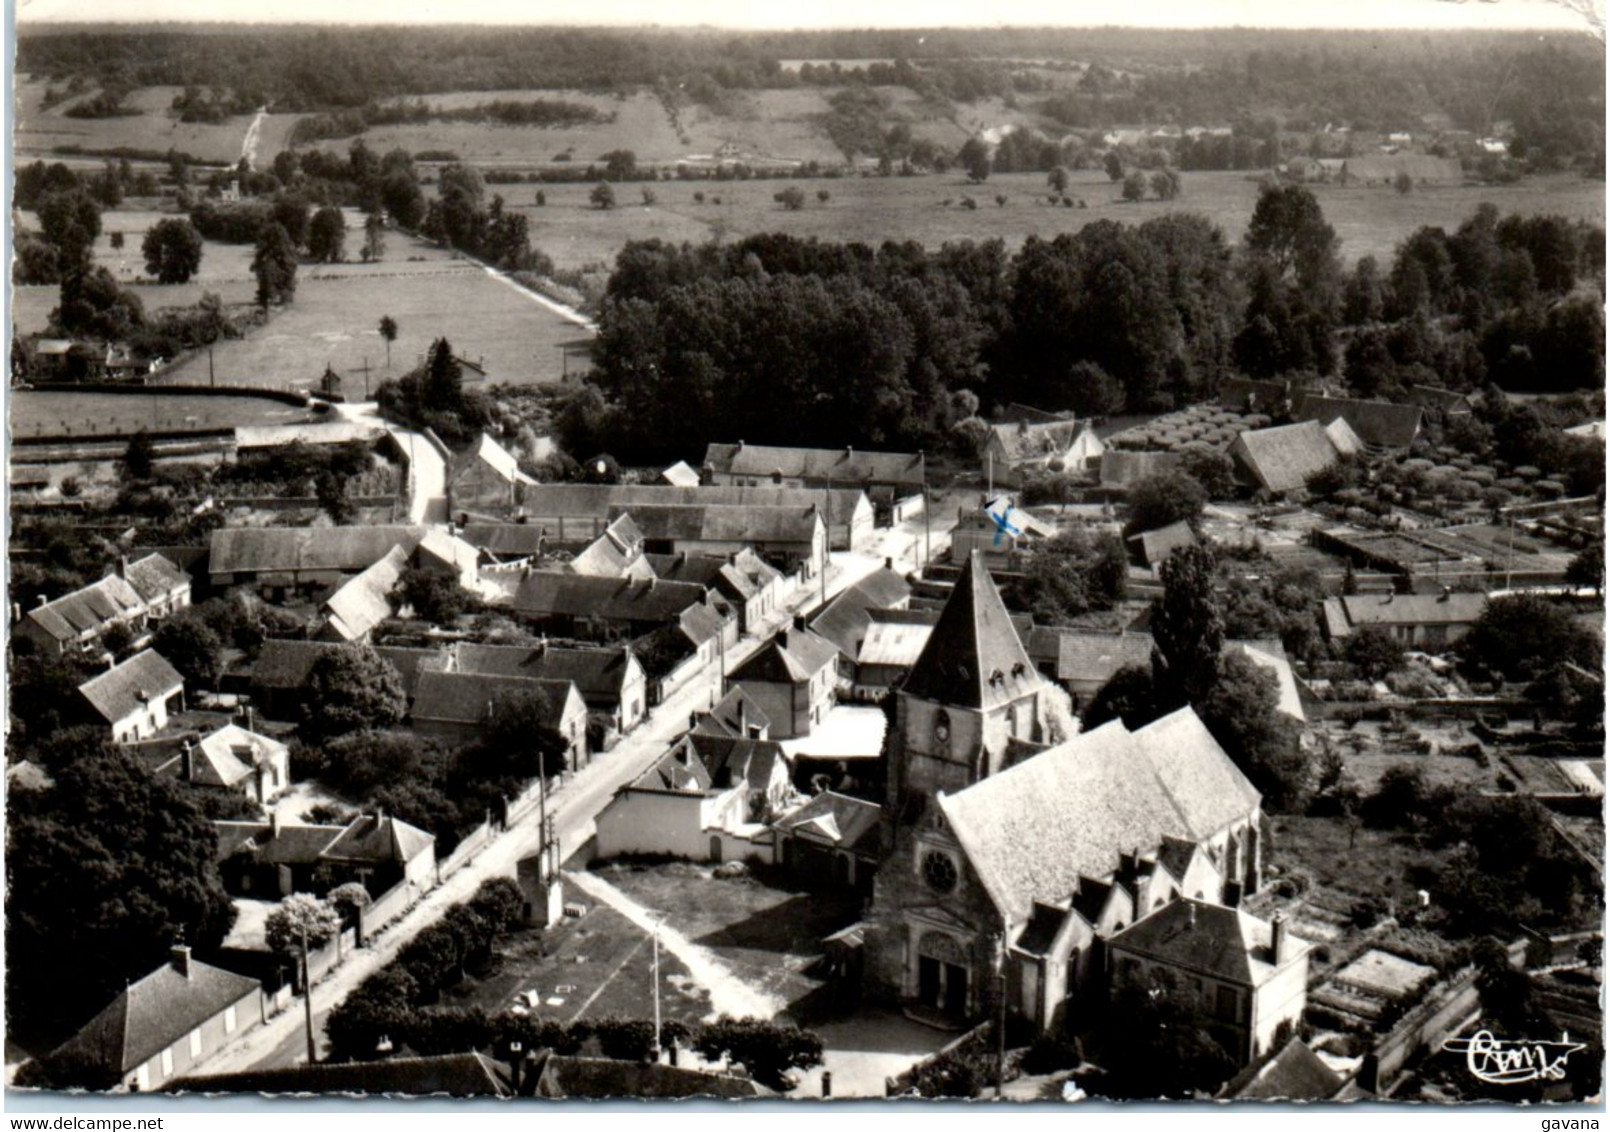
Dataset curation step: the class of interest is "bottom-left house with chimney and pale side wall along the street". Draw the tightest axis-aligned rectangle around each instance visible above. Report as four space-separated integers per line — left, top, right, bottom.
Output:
43 945 266 1093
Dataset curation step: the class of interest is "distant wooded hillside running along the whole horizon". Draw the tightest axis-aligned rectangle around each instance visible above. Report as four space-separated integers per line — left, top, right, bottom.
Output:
18 27 1605 161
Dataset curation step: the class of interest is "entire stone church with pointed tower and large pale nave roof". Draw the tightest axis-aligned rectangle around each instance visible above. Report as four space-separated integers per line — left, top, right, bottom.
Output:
865 556 1262 1029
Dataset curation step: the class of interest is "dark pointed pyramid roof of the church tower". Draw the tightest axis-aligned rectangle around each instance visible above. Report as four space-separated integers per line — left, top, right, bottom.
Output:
905 551 1043 710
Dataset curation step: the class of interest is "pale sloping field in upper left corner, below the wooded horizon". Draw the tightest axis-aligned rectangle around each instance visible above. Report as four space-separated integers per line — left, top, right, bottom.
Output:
13 79 301 164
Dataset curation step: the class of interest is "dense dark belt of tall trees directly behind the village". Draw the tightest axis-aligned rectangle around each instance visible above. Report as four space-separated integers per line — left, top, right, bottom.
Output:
573 190 1604 462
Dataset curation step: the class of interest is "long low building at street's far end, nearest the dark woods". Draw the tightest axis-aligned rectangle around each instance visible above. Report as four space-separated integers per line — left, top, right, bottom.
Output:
699 441 927 523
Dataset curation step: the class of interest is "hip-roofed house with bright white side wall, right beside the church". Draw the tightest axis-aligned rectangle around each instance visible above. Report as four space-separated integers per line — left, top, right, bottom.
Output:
1108 897 1311 1066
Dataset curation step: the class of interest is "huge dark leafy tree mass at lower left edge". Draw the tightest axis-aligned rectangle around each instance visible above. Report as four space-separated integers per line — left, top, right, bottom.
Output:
6 731 235 1037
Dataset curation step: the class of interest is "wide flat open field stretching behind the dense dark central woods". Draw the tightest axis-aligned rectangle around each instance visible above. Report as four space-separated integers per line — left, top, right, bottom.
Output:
488 172 1604 269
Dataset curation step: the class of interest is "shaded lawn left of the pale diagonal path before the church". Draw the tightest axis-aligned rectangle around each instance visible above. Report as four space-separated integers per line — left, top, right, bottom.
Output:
441 890 708 1024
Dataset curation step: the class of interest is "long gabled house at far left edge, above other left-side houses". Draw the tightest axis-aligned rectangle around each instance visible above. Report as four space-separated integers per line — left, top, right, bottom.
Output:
14 554 190 657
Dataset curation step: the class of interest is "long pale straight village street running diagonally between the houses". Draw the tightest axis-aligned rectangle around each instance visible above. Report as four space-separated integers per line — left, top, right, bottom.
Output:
200 520 948 1074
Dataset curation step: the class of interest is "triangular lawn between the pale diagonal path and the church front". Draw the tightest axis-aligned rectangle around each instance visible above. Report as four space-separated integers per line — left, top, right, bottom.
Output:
596 861 861 1026
